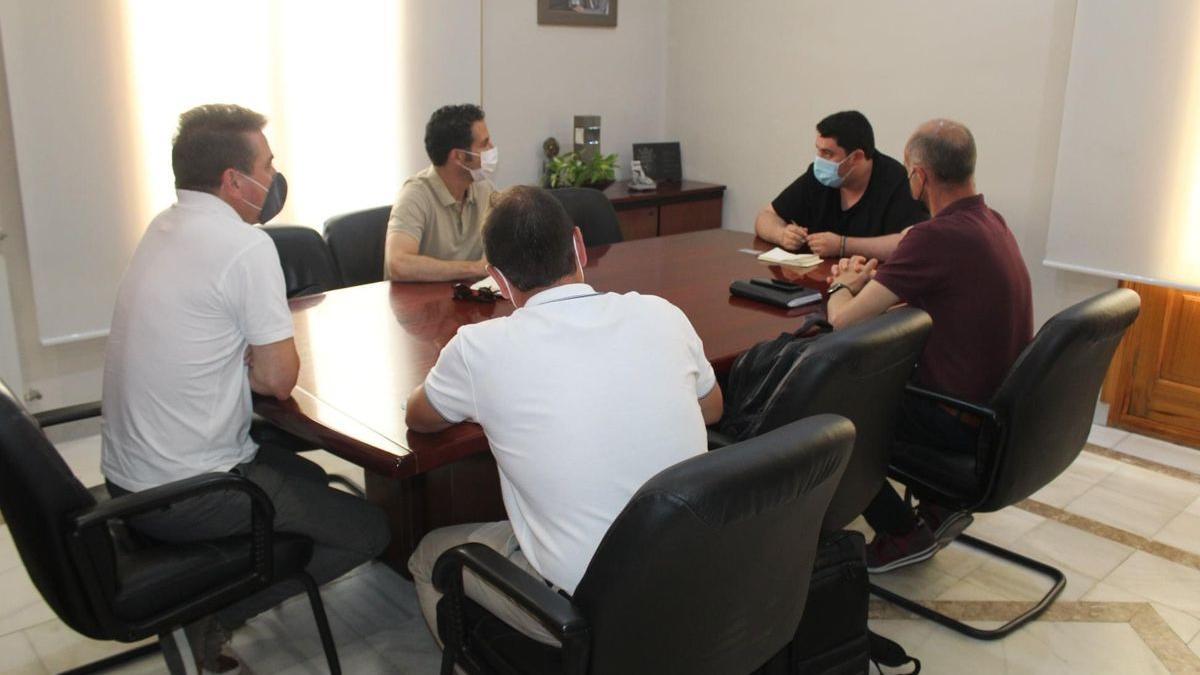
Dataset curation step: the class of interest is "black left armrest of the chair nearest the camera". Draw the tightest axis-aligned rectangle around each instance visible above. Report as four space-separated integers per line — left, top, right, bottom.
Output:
433 543 588 644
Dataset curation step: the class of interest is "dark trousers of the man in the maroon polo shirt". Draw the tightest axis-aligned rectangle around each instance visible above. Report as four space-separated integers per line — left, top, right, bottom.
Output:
863 395 979 534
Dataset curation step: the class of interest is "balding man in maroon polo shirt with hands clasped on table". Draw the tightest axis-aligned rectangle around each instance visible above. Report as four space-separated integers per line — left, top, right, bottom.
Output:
828 120 1033 573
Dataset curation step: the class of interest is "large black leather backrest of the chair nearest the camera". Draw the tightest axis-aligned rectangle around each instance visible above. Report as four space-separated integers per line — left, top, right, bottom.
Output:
574 416 854 675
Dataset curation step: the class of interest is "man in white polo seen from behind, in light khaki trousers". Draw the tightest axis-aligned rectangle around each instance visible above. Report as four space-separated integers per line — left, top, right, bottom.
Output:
407 186 721 644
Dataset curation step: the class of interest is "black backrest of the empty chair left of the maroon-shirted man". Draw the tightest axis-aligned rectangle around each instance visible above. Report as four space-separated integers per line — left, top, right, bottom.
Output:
755 307 934 531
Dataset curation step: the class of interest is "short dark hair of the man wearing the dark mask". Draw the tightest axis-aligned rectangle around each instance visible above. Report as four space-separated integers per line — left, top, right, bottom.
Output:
170 103 266 192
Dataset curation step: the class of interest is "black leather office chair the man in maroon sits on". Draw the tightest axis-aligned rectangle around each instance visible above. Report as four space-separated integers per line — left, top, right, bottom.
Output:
871 288 1141 640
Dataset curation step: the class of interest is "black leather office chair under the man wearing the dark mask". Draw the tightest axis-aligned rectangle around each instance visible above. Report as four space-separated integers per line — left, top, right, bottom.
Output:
0 382 341 673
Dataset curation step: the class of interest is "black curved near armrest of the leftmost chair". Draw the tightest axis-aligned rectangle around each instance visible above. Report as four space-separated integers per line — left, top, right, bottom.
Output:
72 473 275 579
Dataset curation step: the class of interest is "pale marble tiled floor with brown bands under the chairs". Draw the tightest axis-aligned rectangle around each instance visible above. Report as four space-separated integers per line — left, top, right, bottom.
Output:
0 426 1200 675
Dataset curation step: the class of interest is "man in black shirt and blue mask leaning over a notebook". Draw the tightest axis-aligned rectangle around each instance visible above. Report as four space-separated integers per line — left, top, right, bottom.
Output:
754 110 929 261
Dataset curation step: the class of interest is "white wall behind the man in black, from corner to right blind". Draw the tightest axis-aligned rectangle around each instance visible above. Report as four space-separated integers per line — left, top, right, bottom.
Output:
666 0 1112 323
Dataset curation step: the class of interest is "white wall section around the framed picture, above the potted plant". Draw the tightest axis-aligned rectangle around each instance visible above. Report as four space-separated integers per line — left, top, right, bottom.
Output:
482 0 673 187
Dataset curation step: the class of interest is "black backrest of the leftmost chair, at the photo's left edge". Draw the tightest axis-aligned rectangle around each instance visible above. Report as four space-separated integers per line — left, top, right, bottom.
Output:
0 382 106 638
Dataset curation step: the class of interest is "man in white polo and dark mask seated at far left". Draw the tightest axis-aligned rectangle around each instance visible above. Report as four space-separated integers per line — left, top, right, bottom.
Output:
101 104 389 673
